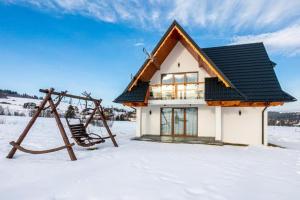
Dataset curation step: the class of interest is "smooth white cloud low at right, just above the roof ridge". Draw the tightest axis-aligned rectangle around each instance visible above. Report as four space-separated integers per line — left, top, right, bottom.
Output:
232 24 300 56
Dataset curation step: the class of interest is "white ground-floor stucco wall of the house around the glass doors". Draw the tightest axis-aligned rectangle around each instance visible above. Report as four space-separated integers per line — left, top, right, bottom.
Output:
137 105 267 145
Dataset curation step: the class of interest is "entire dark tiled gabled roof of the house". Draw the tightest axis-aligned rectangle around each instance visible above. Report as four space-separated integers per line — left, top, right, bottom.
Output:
114 21 296 103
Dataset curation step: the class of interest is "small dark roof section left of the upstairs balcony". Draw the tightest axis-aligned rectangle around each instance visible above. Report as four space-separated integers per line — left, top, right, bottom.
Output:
114 82 149 103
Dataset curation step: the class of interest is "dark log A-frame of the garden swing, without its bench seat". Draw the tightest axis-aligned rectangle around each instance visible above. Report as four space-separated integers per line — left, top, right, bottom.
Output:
7 88 118 161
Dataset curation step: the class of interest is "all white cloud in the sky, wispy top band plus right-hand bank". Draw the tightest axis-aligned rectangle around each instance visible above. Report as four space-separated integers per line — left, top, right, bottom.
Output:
0 0 300 55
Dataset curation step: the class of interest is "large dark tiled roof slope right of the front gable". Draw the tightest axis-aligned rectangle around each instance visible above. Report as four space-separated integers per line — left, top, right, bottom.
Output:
202 43 296 102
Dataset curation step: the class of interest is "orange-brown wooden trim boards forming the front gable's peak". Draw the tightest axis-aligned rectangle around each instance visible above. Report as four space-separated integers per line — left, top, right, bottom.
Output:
128 25 230 91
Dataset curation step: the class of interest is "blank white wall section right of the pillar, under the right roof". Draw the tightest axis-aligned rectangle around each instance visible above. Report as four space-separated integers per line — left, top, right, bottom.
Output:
222 107 263 145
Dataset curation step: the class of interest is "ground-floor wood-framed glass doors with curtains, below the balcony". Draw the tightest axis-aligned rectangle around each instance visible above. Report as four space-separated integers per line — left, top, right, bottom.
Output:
161 108 198 136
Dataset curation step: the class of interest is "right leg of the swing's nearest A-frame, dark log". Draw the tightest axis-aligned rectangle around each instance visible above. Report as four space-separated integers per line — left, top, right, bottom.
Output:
49 98 77 161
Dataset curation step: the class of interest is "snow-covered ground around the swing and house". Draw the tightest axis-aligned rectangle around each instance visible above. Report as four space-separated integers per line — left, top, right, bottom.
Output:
0 116 300 200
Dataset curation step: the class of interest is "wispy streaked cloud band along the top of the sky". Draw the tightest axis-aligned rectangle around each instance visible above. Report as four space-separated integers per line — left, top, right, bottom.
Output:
0 0 300 31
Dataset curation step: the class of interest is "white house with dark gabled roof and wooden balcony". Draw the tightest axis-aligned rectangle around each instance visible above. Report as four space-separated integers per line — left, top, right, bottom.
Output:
114 21 296 144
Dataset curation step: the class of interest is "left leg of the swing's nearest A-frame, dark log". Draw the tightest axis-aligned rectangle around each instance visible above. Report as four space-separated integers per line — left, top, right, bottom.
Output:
7 88 54 158
